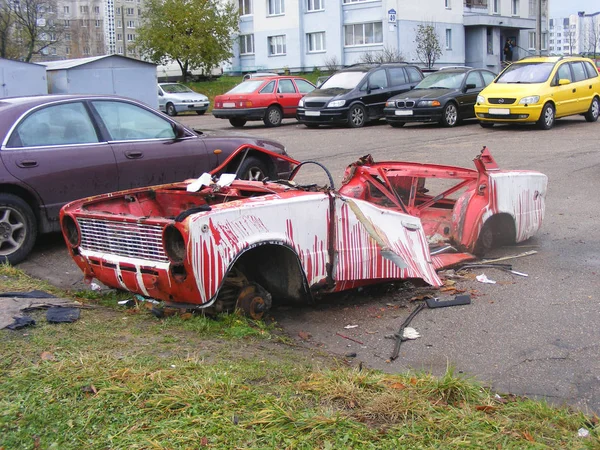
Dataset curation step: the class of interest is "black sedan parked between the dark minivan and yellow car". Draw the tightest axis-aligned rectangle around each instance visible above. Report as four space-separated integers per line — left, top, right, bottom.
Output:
383 67 496 127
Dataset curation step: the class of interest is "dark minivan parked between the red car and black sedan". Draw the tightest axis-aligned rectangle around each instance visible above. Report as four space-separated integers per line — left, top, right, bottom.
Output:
296 63 423 128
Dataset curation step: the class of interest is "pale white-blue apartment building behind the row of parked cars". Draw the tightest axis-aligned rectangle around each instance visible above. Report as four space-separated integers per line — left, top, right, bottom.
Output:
225 0 548 73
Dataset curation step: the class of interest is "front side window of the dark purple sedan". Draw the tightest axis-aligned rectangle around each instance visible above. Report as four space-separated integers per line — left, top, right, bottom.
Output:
92 100 175 141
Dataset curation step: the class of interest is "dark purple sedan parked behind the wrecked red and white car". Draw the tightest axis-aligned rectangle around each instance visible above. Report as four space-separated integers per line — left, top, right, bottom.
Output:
0 95 290 264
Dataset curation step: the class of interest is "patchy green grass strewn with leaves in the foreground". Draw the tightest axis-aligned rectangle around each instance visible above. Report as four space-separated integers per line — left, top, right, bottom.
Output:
0 266 600 449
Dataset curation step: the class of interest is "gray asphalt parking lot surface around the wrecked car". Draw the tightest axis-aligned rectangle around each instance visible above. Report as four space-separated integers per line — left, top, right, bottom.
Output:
19 115 600 413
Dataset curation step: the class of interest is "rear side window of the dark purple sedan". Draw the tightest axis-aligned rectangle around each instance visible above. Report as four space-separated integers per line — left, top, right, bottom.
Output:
7 102 99 148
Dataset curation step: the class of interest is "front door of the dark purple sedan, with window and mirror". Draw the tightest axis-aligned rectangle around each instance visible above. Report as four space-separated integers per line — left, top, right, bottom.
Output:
91 100 212 189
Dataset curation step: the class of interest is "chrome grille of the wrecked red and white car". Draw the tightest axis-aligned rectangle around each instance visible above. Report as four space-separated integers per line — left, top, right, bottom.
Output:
77 218 169 262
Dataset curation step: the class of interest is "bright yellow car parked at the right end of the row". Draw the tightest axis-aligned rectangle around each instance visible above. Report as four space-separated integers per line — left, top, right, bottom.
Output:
475 56 600 130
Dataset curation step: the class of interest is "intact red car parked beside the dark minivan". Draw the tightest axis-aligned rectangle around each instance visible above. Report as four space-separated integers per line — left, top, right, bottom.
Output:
212 76 315 128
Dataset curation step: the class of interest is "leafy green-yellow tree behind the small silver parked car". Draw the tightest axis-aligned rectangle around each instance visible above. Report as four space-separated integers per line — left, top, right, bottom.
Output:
135 0 238 82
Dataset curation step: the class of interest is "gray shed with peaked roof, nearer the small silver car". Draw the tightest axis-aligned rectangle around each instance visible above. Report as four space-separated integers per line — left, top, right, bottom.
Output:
41 55 158 108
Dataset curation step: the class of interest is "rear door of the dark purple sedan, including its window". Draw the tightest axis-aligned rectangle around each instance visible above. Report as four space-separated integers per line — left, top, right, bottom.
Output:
0 101 118 220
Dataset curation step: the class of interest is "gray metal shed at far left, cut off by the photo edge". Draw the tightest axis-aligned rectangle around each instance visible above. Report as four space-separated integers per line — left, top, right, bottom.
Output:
0 58 48 98
